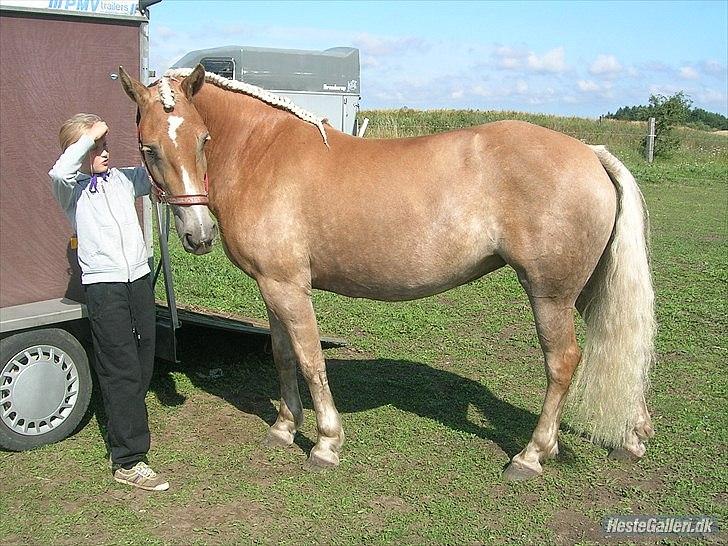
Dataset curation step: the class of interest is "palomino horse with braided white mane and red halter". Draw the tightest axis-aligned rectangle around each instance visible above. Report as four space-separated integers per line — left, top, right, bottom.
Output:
120 65 655 479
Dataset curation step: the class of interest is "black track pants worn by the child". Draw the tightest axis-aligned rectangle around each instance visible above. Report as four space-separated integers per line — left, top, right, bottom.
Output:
86 275 156 466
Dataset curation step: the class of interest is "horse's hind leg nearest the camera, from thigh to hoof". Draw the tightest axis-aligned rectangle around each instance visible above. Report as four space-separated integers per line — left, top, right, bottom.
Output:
505 296 581 480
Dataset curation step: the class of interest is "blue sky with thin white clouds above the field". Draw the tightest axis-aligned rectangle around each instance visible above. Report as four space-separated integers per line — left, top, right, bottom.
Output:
150 0 728 117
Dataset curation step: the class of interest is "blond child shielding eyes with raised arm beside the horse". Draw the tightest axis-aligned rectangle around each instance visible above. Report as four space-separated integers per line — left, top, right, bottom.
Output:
48 114 169 491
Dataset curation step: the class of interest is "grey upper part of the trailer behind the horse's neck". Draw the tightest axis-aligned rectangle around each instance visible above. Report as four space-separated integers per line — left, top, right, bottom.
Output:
172 45 359 95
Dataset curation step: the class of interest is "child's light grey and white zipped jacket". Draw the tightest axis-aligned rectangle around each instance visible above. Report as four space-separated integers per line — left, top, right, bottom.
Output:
48 135 150 284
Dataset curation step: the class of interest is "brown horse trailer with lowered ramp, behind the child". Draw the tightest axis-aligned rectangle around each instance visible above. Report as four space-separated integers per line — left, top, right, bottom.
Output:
0 0 344 451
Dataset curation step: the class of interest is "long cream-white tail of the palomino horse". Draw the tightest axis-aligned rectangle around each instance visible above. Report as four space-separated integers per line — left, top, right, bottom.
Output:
570 146 657 447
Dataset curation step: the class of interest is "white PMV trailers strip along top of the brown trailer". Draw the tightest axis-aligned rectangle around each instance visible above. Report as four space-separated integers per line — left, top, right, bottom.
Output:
0 0 148 21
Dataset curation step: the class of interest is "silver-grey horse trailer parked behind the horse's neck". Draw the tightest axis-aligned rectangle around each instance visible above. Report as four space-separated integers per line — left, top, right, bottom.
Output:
172 46 361 135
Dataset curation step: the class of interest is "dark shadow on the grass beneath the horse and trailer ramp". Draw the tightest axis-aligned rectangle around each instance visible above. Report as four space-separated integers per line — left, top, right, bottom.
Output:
152 327 538 457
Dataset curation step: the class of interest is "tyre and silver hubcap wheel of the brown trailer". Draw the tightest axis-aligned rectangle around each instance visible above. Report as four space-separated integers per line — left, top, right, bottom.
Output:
0 328 92 451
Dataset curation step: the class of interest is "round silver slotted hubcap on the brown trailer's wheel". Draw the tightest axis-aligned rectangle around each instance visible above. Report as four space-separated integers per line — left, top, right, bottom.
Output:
0 345 78 436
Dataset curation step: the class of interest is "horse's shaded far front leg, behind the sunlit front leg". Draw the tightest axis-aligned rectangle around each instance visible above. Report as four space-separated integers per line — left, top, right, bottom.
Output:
265 312 303 447
